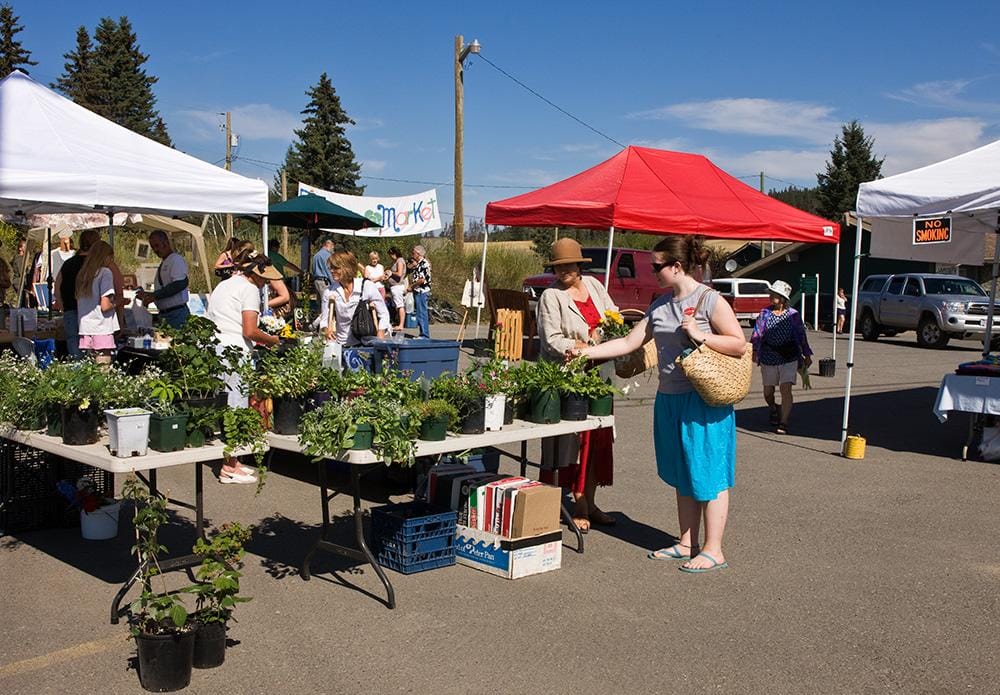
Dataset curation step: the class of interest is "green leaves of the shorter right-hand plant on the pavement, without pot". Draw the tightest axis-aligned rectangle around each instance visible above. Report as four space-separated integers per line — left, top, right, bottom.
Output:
188 523 251 625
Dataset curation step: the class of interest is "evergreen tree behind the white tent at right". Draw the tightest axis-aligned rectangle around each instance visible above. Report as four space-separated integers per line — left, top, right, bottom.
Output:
816 121 885 221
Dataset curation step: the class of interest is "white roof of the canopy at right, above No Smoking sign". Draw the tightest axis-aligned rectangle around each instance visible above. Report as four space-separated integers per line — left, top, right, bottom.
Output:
857 140 1000 219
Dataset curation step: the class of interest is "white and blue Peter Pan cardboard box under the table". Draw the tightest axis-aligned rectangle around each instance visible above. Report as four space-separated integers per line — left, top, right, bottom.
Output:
455 524 562 579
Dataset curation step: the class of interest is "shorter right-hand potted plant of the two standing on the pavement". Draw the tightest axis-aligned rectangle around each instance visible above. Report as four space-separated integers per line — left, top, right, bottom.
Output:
188 523 250 668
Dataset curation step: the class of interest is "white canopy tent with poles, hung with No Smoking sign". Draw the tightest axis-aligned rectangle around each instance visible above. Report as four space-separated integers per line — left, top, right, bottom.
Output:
840 140 1000 448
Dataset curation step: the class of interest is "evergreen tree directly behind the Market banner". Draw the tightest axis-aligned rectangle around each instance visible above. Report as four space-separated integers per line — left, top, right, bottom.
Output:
275 72 365 195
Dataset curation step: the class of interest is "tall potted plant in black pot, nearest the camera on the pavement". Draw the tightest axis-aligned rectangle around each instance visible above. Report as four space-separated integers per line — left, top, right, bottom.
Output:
122 476 195 692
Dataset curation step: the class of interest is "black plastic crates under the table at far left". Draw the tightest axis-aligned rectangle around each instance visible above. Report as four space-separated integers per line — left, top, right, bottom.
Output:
0 439 114 533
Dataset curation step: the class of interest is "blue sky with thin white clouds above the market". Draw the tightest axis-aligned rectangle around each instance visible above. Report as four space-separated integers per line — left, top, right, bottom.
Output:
12 0 1000 223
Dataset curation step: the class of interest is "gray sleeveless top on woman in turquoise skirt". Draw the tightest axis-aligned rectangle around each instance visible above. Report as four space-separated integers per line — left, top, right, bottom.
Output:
646 285 719 393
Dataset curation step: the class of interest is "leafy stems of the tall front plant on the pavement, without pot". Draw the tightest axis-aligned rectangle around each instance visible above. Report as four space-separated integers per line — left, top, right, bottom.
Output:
122 475 190 635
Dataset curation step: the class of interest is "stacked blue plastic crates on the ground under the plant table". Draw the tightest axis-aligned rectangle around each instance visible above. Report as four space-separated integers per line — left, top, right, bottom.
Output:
372 502 458 574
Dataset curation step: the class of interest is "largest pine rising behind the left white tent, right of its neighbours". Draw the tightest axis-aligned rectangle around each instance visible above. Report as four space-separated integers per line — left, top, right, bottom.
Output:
86 17 172 145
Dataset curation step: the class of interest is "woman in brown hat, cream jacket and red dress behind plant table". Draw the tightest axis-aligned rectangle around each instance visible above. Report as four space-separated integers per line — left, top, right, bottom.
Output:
538 238 618 533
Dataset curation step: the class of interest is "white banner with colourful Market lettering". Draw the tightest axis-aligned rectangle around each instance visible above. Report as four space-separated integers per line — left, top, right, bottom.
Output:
299 183 443 238
